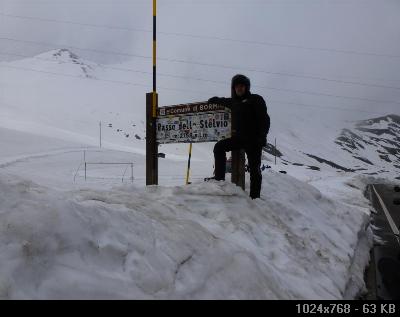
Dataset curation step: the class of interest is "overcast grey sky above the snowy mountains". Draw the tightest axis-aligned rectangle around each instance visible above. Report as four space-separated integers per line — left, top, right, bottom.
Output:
0 0 400 114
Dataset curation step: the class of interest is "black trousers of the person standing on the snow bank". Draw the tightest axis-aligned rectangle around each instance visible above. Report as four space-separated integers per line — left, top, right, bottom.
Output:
214 138 262 199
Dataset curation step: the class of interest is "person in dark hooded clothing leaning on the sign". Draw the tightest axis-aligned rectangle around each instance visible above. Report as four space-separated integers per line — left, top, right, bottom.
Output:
208 75 270 199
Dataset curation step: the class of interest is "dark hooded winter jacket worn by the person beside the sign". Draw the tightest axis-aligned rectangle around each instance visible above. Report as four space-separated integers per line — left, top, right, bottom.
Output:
209 75 270 146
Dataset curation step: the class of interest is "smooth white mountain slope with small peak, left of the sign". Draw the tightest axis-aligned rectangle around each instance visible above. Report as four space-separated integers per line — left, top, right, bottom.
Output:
0 49 145 153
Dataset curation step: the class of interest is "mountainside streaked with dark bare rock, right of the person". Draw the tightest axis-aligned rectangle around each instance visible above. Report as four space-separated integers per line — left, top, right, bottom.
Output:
266 115 400 178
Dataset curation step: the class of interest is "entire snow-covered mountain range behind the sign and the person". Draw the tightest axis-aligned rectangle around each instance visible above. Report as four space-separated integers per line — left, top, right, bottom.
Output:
0 49 399 173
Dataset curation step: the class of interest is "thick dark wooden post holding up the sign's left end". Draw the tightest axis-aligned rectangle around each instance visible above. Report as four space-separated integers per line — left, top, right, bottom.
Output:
146 93 158 186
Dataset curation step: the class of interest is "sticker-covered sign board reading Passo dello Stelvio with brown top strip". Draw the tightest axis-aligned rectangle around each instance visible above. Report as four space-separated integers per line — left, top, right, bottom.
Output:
156 102 231 144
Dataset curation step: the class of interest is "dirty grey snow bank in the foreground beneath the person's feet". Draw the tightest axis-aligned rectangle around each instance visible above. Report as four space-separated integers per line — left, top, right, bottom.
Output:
0 172 369 299
